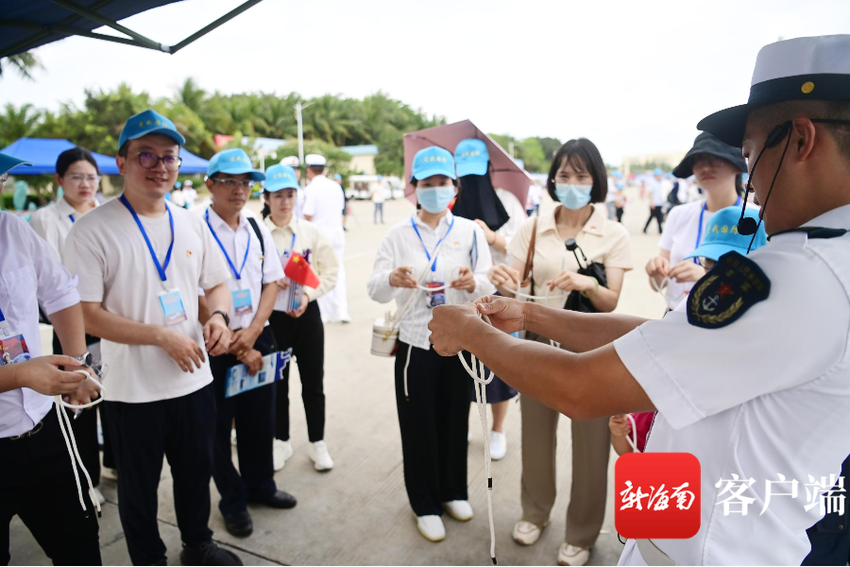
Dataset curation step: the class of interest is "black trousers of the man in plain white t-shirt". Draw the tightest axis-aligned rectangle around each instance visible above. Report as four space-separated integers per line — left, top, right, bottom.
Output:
104 384 215 565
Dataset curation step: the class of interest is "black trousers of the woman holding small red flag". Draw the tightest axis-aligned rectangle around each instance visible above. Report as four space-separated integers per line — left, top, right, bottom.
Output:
269 301 325 443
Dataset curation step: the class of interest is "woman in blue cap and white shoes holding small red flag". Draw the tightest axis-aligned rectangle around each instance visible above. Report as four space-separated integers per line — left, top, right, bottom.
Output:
263 165 339 472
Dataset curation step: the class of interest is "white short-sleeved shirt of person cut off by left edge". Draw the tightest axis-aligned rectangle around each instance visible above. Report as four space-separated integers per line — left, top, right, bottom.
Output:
0 212 80 439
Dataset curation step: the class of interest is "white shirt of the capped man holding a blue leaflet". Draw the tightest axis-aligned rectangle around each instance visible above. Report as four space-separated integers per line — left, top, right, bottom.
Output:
205 207 285 331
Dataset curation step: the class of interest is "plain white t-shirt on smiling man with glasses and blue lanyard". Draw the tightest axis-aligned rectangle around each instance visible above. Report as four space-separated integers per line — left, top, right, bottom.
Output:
64 199 228 403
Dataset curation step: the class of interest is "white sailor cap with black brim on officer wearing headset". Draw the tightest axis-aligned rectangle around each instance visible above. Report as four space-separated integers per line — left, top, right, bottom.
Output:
697 35 850 147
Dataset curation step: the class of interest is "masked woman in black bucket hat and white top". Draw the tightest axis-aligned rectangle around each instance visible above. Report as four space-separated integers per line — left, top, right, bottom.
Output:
646 132 747 309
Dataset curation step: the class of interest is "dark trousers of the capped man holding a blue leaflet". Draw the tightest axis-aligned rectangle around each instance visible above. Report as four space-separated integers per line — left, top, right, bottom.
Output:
210 327 277 516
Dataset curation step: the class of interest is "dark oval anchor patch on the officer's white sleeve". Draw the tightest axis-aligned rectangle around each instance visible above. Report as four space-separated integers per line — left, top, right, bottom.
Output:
688 252 770 329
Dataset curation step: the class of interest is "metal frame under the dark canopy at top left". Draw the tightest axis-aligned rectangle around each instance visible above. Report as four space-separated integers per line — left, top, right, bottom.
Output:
0 0 262 58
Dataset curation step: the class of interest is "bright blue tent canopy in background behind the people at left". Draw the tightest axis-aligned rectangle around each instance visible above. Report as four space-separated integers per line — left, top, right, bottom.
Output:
0 138 209 176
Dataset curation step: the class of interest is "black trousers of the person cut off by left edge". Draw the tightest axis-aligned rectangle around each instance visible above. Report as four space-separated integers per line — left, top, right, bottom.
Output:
0 407 101 566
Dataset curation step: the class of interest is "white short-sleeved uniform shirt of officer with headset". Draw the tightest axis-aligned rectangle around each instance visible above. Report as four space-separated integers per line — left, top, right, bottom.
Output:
614 206 850 566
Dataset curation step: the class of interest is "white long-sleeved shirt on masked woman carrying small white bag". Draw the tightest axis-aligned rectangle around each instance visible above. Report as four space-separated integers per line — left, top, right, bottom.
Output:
367 212 496 350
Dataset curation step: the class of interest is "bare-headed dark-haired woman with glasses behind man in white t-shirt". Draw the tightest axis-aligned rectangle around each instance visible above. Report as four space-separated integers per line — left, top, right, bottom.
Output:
30 147 107 504
